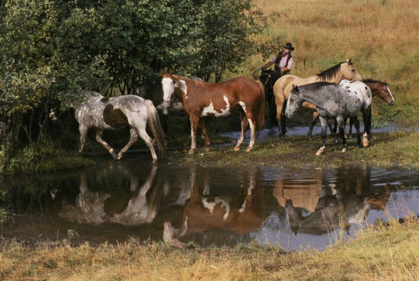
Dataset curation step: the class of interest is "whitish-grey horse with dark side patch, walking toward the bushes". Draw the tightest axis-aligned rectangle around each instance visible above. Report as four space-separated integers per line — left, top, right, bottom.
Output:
50 91 166 162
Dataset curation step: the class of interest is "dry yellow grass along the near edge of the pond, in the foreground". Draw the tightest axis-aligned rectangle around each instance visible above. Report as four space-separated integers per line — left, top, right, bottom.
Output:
0 219 419 281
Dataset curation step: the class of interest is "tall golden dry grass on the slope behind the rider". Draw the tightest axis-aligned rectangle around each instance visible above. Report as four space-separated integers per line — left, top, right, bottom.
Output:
236 0 419 122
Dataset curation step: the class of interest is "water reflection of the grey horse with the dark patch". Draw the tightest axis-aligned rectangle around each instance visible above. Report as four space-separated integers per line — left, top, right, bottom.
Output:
59 165 161 226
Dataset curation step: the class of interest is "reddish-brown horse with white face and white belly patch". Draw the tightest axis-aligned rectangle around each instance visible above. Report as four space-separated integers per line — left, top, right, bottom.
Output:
160 72 265 154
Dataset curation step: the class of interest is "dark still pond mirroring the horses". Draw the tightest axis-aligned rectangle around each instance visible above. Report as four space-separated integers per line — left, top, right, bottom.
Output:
0 158 419 250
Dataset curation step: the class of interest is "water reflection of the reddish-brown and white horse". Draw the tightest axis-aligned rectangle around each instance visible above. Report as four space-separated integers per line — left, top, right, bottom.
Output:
163 168 265 241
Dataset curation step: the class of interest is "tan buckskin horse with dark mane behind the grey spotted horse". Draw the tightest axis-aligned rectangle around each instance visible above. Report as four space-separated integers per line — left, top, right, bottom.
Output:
274 59 362 137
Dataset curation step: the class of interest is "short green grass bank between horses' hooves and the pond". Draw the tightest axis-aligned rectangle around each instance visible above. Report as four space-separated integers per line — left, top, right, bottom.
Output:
169 131 419 168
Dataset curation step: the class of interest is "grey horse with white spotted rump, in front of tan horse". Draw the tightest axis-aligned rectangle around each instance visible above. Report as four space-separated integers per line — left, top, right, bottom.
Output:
285 81 372 155
